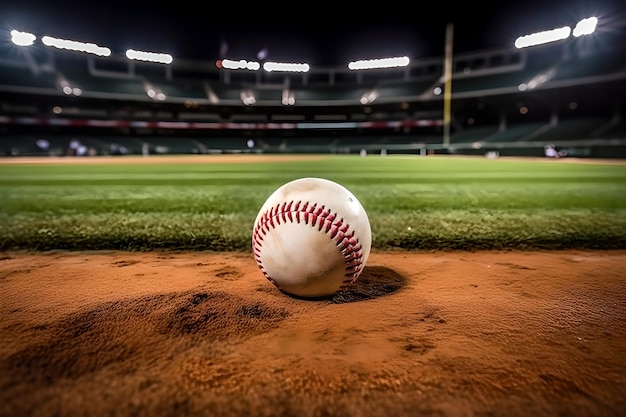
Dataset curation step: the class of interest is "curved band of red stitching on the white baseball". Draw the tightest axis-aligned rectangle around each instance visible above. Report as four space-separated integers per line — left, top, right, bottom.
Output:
252 200 363 290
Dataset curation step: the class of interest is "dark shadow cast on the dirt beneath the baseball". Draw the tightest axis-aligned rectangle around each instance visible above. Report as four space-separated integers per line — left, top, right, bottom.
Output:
285 266 407 304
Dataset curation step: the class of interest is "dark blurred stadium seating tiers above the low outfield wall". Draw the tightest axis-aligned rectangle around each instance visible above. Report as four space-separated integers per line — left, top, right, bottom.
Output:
0 26 626 158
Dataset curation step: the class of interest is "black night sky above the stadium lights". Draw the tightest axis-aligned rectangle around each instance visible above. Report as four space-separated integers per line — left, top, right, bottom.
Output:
0 0 626 66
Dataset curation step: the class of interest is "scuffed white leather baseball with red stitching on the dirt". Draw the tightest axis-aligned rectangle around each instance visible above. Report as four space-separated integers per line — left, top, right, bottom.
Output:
252 178 372 298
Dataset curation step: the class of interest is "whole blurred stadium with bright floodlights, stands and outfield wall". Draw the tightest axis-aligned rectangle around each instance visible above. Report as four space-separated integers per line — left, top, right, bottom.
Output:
0 11 626 158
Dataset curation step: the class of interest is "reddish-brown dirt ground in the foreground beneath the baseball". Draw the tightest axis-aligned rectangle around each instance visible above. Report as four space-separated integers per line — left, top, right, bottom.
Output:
0 251 626 417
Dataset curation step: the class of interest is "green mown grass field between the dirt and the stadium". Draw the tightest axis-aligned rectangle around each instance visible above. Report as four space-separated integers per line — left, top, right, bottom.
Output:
0 156 626 251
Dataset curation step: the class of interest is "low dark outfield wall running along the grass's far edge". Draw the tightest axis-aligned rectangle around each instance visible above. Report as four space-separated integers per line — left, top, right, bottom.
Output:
0 136 626 158
